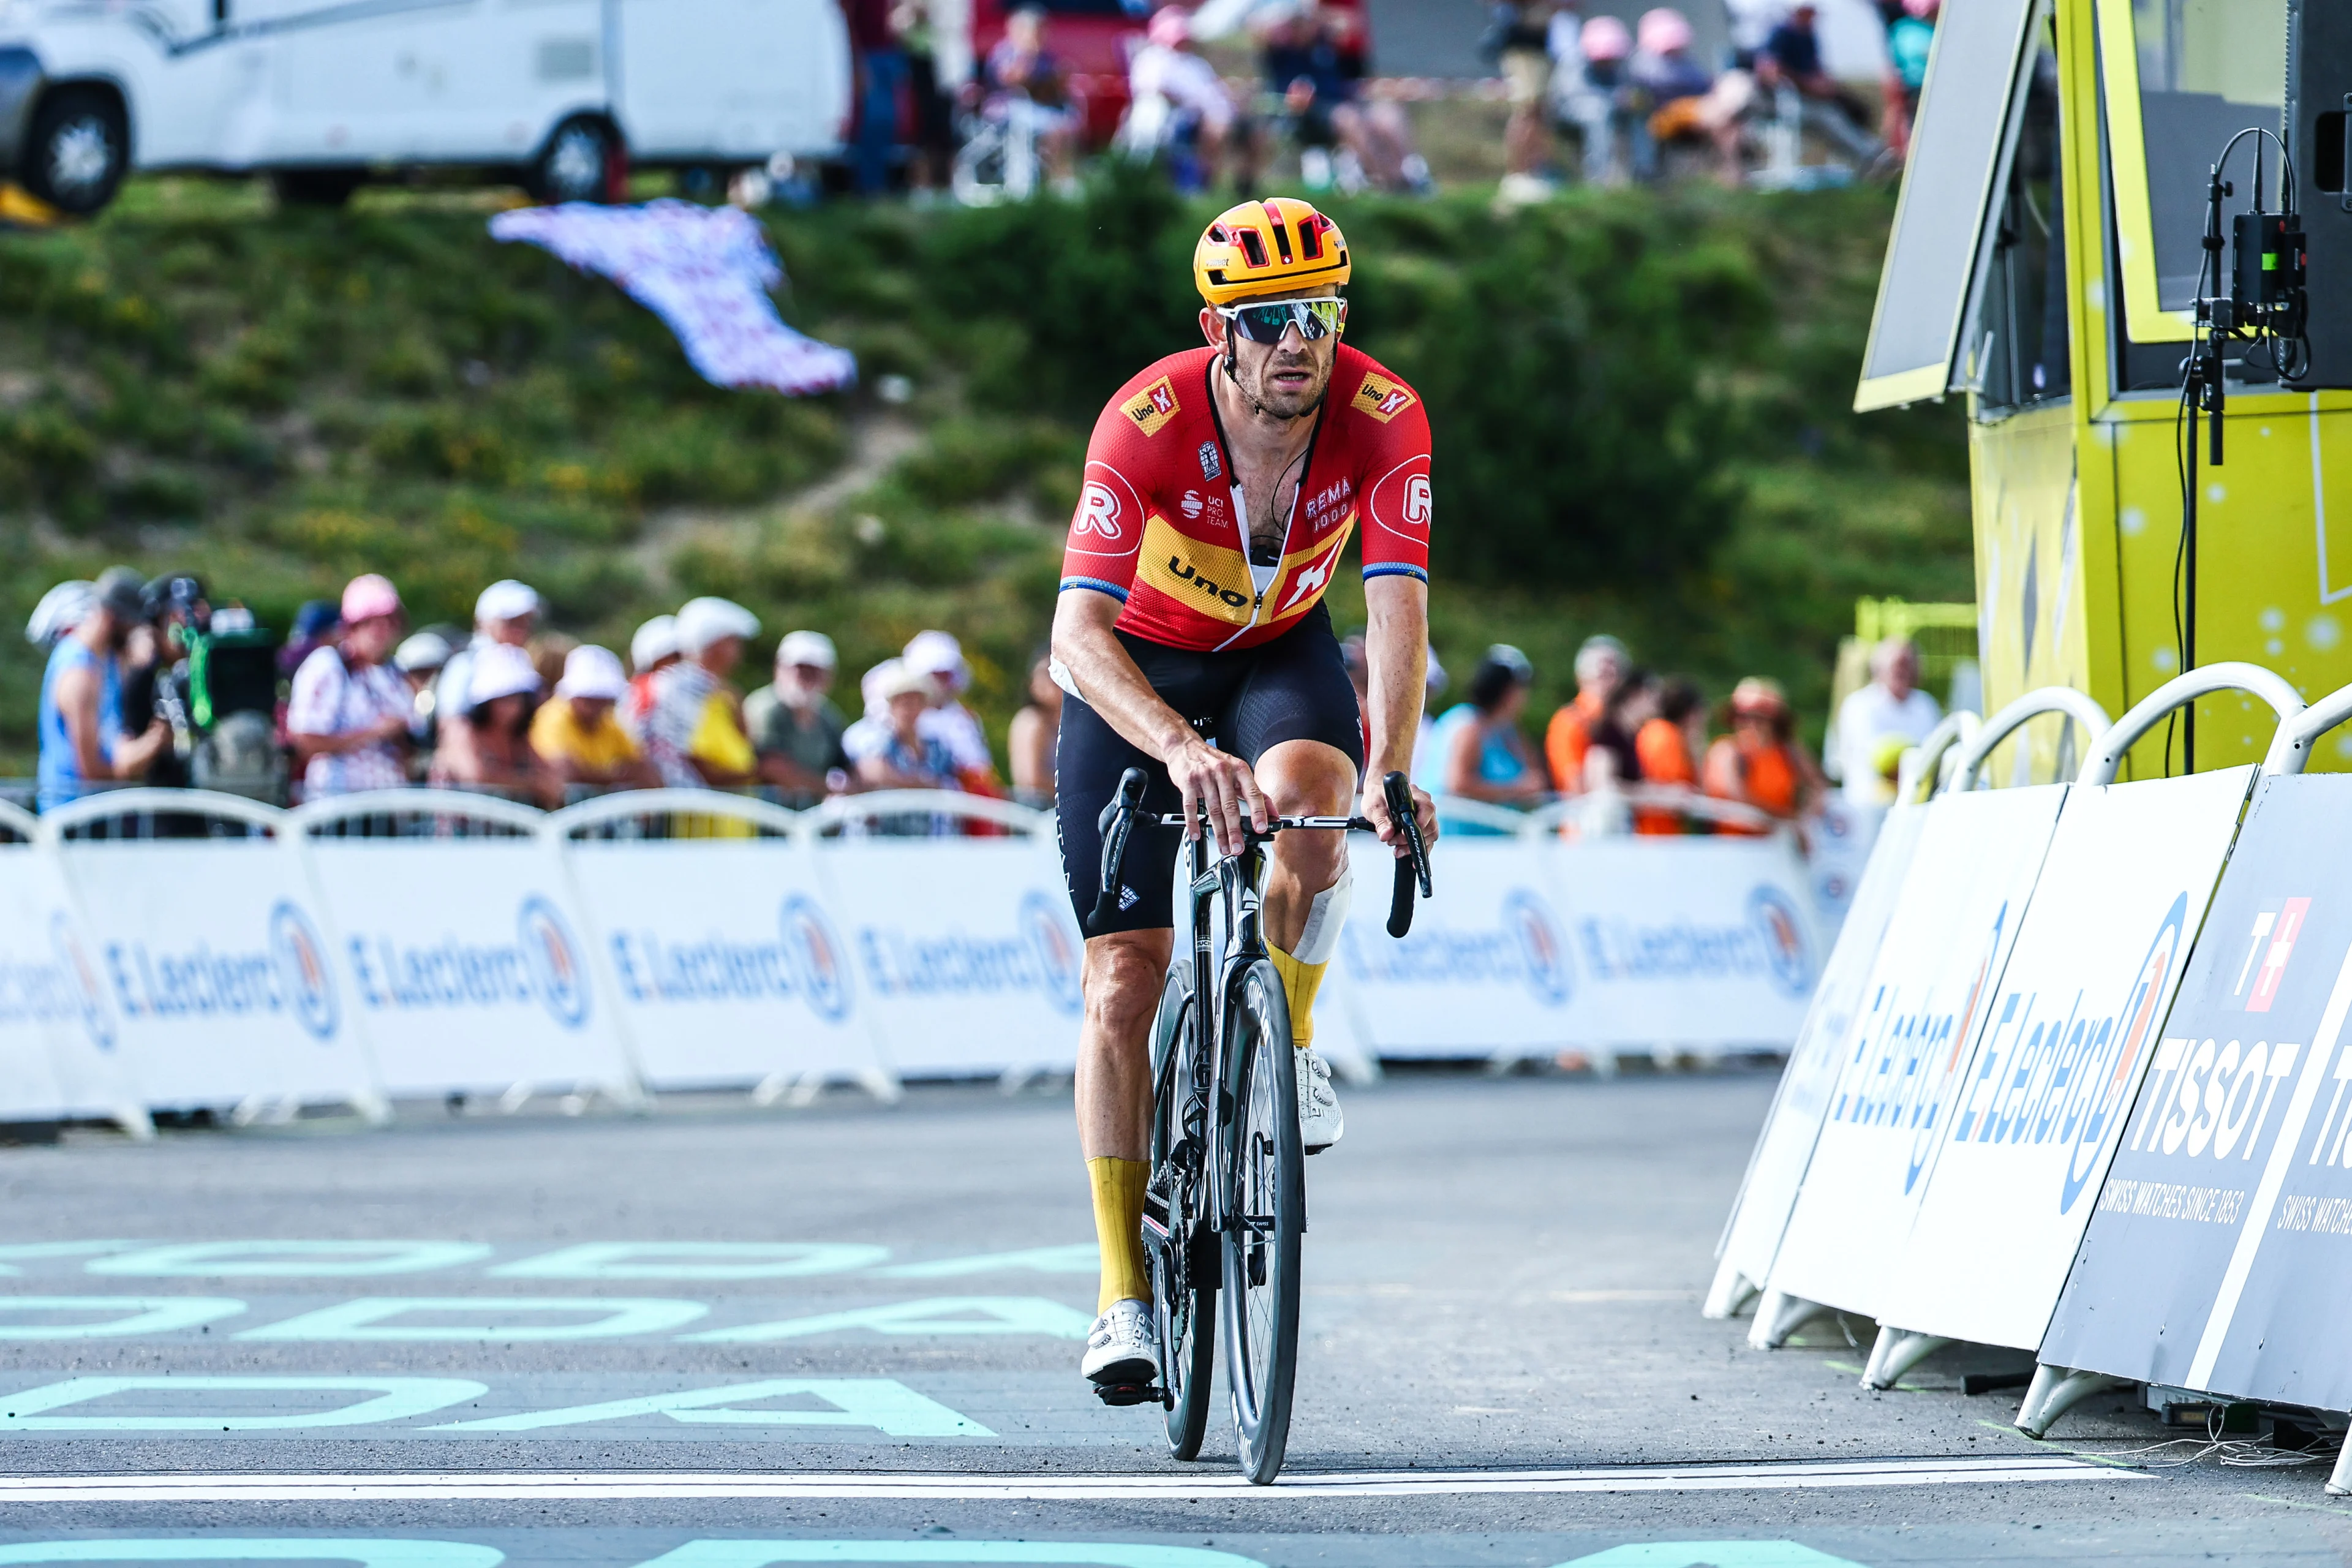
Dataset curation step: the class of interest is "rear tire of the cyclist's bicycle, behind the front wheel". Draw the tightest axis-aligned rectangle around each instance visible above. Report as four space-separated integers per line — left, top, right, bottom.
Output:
1143 959 1216 1460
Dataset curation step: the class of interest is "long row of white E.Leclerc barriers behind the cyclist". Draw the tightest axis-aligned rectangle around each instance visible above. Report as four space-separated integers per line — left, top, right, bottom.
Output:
0 790 1851 1131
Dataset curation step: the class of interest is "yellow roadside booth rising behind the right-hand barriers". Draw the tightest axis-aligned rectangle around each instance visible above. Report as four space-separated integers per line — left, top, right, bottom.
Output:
1856 0 2352 780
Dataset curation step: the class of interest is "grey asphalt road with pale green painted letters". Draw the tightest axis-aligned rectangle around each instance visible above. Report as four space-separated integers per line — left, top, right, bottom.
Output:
0 1072 2352 1568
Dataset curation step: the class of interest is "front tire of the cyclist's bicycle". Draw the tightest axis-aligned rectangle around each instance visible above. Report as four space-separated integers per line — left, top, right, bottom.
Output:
1221 959 1308 1486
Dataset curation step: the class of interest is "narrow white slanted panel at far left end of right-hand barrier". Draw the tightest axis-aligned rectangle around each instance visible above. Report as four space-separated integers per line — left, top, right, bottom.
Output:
1710 806 1926 1300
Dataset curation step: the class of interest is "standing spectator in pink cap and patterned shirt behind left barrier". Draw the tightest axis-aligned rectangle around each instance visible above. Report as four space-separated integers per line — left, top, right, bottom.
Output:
287 571 417 799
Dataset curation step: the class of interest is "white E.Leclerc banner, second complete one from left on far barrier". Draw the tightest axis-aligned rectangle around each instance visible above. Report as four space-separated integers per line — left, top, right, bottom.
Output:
308 837 654 1098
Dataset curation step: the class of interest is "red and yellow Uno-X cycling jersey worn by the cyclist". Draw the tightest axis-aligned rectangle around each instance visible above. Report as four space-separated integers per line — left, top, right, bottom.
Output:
1061 345 1430 649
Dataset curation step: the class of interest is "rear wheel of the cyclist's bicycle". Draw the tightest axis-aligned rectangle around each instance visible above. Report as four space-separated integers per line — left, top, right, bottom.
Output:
1143 959 1216 1460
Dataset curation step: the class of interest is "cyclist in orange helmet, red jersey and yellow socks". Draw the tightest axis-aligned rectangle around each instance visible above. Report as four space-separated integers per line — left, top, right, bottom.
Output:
1054 197 1437 1385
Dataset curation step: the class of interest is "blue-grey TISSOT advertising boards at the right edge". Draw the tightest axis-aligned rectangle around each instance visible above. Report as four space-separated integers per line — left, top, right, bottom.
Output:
2039 774 2352 1411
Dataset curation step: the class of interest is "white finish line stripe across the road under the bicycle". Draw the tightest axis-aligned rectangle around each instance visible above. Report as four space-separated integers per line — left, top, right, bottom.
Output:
0 1455 2147 1504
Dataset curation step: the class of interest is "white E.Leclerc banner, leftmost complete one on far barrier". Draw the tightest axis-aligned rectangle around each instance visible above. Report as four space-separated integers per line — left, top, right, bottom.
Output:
54 837 376 1110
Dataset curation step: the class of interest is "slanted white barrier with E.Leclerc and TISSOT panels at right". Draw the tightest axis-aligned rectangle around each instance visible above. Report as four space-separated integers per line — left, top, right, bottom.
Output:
1708 665 2352 1457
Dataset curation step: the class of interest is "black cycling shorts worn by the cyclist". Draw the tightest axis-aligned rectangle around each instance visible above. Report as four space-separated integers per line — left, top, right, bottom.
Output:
1054 604 1364 936
